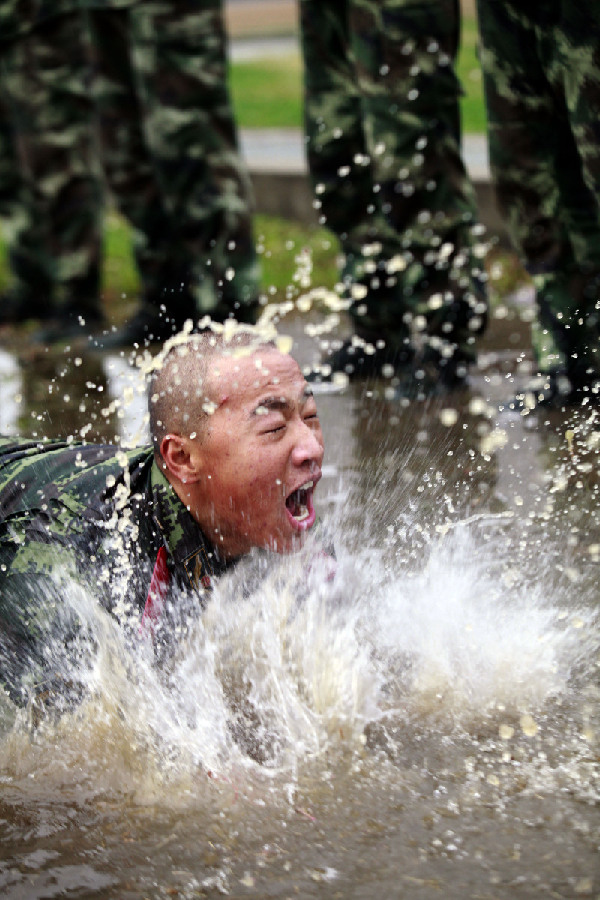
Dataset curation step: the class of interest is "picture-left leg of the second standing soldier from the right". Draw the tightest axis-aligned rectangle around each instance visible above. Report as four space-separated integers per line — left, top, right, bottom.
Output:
300 0 424 378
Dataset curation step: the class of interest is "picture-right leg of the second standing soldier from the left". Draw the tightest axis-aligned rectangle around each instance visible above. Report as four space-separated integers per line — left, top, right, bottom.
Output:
132 0 259 321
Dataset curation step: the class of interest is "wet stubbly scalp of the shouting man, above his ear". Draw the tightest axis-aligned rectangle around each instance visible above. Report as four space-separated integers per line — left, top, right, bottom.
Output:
148 327 274 456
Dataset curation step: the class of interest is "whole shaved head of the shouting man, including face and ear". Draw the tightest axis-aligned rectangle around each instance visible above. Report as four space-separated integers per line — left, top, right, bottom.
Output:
144 322 323 558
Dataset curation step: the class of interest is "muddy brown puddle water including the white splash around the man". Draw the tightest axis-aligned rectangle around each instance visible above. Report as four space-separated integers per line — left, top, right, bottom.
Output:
0 312 600 900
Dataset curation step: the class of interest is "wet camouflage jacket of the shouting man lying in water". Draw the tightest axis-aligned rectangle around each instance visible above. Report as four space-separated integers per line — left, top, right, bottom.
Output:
0 438 233 704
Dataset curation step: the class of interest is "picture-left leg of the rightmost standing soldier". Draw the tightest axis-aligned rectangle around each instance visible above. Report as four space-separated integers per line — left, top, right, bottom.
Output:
478 0 598 402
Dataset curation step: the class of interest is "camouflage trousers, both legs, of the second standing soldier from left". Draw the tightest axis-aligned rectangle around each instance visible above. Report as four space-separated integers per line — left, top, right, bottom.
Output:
88 0 259 320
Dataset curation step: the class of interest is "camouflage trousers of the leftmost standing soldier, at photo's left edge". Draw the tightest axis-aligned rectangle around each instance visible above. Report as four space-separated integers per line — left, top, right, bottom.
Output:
0 13 102 318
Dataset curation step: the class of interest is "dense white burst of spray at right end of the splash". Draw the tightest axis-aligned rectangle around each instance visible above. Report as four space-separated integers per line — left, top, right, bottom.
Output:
372 527 594 728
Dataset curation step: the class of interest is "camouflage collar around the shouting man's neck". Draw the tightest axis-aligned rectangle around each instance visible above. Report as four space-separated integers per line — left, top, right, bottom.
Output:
150 461 227 591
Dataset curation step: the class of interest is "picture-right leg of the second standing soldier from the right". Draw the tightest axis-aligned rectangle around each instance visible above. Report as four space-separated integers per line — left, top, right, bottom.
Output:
358 0 487 376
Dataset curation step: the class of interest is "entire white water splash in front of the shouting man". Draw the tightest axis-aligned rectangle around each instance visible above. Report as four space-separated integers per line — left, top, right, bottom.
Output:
0 502 600 801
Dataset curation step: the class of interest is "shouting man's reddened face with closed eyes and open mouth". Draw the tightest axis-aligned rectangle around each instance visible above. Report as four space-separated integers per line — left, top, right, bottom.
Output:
192 349 323 556
